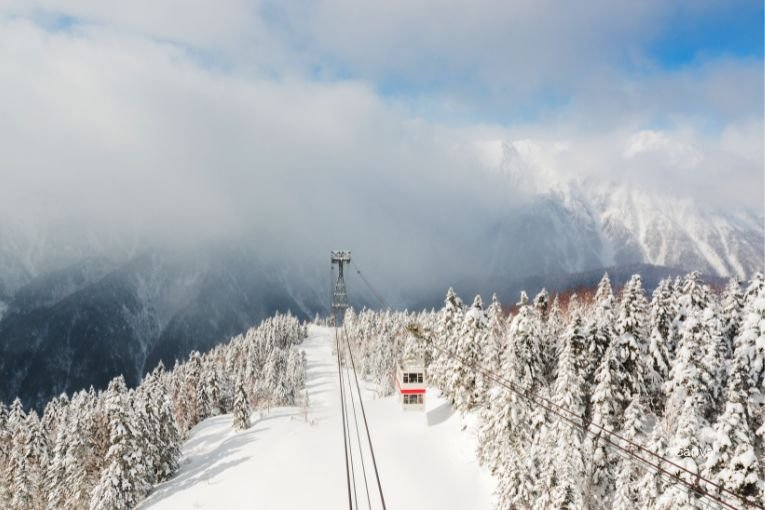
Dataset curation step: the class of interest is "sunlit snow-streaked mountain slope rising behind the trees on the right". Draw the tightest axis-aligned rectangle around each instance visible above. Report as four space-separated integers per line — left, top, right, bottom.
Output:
486 142 765 278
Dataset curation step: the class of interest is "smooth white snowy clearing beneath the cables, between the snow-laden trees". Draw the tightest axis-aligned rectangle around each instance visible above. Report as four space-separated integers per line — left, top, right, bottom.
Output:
139 327 494 510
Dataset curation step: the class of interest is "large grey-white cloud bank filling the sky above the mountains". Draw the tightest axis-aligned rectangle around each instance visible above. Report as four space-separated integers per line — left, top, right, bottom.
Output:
0 0 763 290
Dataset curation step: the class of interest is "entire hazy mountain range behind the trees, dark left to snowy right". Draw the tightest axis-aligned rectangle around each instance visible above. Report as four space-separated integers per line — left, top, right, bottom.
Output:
0 143 765 406
